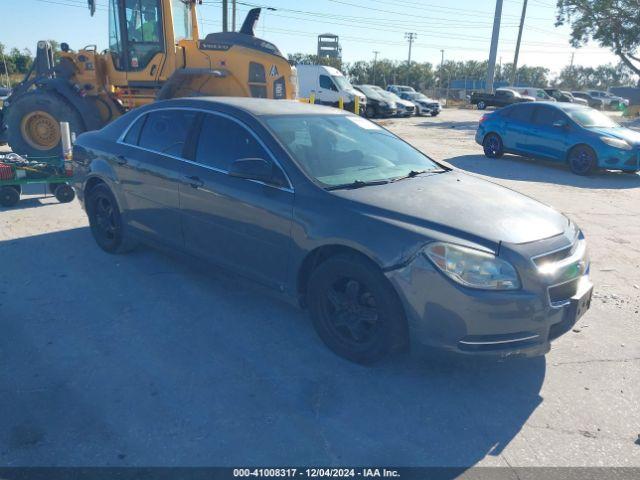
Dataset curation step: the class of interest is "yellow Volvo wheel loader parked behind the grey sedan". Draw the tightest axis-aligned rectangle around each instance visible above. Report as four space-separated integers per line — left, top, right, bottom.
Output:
0 0 297 157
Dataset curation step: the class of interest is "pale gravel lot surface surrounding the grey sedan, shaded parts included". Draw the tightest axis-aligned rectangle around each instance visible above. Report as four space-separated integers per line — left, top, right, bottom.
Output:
0 110 640 467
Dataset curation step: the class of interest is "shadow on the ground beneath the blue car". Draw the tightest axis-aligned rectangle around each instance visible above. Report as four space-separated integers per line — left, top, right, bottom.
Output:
444 155 640 189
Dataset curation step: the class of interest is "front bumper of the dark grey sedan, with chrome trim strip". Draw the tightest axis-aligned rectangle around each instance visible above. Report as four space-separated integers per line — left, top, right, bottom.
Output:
387 231 593 357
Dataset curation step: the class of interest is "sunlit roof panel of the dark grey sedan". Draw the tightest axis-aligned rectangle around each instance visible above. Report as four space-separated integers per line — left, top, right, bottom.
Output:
151 97 350 116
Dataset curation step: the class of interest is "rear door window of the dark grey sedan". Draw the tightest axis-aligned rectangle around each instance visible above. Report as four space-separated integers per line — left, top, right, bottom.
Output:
138 110 197 157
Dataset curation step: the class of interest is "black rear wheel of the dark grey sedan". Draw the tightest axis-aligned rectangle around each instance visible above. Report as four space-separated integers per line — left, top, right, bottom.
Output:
86 183 135 253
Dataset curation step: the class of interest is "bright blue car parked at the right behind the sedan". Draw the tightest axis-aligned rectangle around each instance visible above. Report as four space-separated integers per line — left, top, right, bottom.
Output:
476 102 640 175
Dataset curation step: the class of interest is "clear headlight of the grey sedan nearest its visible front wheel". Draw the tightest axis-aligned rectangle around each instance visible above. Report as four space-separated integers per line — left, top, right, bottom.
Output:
424 242 520 290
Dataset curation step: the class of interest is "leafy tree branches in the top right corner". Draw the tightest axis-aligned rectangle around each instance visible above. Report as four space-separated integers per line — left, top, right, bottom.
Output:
556 0 640 85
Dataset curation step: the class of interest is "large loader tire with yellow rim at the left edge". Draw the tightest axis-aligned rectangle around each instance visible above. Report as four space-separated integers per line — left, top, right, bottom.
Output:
7 91 85 157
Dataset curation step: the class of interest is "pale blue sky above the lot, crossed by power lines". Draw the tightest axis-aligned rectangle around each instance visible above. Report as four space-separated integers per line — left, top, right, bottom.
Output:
0 0 617 73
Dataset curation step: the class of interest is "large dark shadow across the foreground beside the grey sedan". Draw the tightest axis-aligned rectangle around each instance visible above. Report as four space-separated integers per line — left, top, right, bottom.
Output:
0 228 545 466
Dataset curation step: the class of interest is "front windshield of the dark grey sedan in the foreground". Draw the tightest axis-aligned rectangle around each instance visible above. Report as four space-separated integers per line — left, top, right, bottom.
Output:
265 115 444 188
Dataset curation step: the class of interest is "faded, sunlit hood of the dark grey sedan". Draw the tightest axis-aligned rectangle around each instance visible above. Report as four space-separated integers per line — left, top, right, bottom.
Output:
331 171 569 250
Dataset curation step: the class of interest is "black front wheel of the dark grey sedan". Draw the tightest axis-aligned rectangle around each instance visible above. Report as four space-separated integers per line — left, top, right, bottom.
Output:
307 254 408 365
